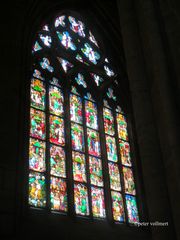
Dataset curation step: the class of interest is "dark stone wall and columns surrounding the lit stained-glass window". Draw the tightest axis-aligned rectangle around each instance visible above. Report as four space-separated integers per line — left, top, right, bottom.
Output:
0 0 180 240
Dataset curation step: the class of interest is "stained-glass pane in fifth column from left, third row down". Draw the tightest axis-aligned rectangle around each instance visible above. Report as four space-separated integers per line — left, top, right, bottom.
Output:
108 162 121 191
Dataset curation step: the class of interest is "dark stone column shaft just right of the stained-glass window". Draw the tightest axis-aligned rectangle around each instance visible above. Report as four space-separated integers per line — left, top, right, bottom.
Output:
117 0 176 240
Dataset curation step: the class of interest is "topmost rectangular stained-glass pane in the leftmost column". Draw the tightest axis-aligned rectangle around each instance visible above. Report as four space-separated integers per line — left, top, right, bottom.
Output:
31 79 46 110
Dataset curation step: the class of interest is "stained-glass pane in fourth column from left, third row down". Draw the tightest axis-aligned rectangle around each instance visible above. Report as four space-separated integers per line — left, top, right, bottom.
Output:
89 156 103 187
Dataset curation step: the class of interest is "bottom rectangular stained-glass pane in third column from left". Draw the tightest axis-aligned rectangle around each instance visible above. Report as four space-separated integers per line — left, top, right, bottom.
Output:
74 183 89 215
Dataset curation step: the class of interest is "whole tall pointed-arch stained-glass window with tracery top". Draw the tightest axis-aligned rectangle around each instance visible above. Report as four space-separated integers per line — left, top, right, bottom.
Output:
28 12 139 224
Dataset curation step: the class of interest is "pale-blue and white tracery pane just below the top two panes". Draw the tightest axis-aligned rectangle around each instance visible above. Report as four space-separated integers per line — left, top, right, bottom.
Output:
56 31 77 51
